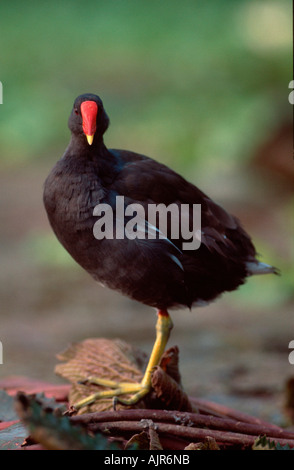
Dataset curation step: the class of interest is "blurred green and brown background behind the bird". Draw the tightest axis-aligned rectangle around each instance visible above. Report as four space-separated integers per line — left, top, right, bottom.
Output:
0 0 294 422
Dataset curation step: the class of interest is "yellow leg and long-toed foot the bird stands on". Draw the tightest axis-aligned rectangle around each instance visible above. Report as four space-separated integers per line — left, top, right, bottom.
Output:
74 310 173 409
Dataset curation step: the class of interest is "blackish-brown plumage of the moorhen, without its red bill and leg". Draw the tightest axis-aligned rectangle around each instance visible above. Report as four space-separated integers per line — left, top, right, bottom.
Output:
44 94 275 309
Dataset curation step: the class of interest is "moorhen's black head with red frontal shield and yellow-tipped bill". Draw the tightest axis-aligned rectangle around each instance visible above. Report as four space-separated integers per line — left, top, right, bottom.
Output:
68 93 109 145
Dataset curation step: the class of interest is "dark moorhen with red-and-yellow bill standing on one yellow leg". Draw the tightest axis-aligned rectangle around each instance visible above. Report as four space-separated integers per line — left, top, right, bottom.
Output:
43 93 278 409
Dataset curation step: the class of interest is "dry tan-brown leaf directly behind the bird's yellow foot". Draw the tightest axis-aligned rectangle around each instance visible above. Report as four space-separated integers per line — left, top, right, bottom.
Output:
55 338 146 414
